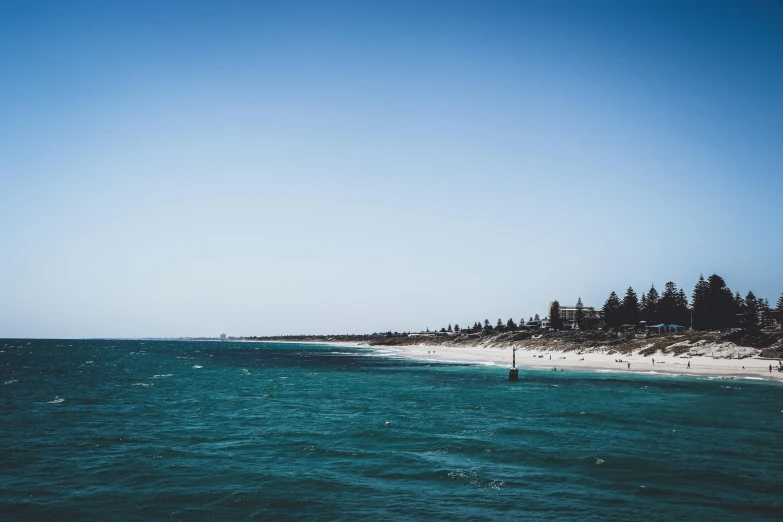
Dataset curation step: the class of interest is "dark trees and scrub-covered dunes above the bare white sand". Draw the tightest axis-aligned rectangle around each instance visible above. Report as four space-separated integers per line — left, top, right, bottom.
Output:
243 274 783 359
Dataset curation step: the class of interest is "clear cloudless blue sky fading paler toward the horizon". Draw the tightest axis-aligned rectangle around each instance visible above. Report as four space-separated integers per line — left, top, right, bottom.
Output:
0 0 783 337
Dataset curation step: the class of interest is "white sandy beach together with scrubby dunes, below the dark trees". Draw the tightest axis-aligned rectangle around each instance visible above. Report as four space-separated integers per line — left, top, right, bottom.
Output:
244 332 783 381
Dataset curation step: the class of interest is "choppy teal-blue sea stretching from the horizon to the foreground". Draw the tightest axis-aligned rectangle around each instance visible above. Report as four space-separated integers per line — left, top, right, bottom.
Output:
0 340 783 520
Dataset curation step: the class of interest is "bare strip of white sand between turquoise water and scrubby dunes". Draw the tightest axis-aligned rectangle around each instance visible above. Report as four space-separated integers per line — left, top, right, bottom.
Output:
364 343 783 381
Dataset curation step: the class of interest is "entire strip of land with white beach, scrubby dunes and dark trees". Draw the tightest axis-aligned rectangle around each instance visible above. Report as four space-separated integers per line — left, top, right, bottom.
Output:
242 274 783 379
